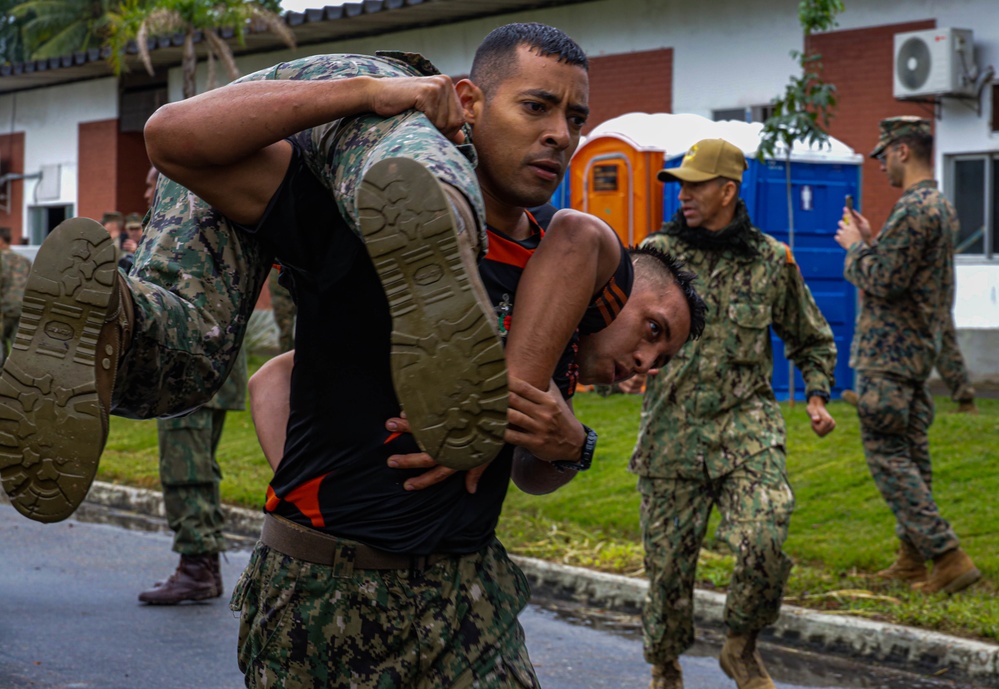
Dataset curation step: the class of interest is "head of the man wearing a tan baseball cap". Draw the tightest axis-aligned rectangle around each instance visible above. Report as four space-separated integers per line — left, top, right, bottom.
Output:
657 139 747 231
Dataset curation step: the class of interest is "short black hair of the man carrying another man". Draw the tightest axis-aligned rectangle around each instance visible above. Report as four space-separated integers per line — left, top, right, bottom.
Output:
469 22 590 93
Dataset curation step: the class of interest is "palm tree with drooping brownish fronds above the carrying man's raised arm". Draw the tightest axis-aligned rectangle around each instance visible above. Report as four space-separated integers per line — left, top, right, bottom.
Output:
107 0 295 98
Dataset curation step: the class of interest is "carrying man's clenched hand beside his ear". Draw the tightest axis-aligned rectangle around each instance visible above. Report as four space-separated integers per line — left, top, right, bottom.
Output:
369 74 465 144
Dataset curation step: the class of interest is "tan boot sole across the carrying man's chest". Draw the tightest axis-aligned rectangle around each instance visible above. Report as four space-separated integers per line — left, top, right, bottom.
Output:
356 158 507 469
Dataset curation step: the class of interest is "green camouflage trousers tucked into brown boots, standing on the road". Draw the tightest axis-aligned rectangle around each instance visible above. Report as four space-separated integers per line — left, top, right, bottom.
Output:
156 407 226 555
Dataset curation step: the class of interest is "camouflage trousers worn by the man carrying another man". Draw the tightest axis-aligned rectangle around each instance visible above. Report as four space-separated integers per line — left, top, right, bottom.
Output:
229 541 539 689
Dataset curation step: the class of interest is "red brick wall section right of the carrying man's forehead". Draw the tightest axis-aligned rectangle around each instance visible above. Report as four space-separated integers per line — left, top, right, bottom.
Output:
583 48 673 134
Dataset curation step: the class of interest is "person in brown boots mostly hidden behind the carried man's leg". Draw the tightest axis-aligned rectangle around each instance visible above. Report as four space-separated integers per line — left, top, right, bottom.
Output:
139 351 247 605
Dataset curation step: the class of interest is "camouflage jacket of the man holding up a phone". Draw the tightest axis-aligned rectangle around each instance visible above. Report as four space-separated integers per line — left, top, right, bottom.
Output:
843 180 958 381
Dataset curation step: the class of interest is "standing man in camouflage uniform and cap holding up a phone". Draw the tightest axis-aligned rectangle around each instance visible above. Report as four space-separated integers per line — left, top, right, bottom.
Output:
836 117 981 593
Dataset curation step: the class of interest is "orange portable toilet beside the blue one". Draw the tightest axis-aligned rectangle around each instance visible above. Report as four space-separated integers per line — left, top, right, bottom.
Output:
568 134 663 246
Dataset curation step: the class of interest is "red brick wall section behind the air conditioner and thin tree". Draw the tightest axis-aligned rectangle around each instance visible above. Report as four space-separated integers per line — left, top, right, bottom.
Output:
807 20 936 229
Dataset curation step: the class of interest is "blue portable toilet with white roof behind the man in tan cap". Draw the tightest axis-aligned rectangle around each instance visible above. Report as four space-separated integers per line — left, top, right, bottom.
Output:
660 115 863 400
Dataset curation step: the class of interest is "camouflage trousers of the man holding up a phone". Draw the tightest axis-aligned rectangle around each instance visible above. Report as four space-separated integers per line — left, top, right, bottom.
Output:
857 372 958 560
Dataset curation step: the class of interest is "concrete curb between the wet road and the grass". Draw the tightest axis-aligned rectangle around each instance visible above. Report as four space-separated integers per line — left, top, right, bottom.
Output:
23 482 999 687
